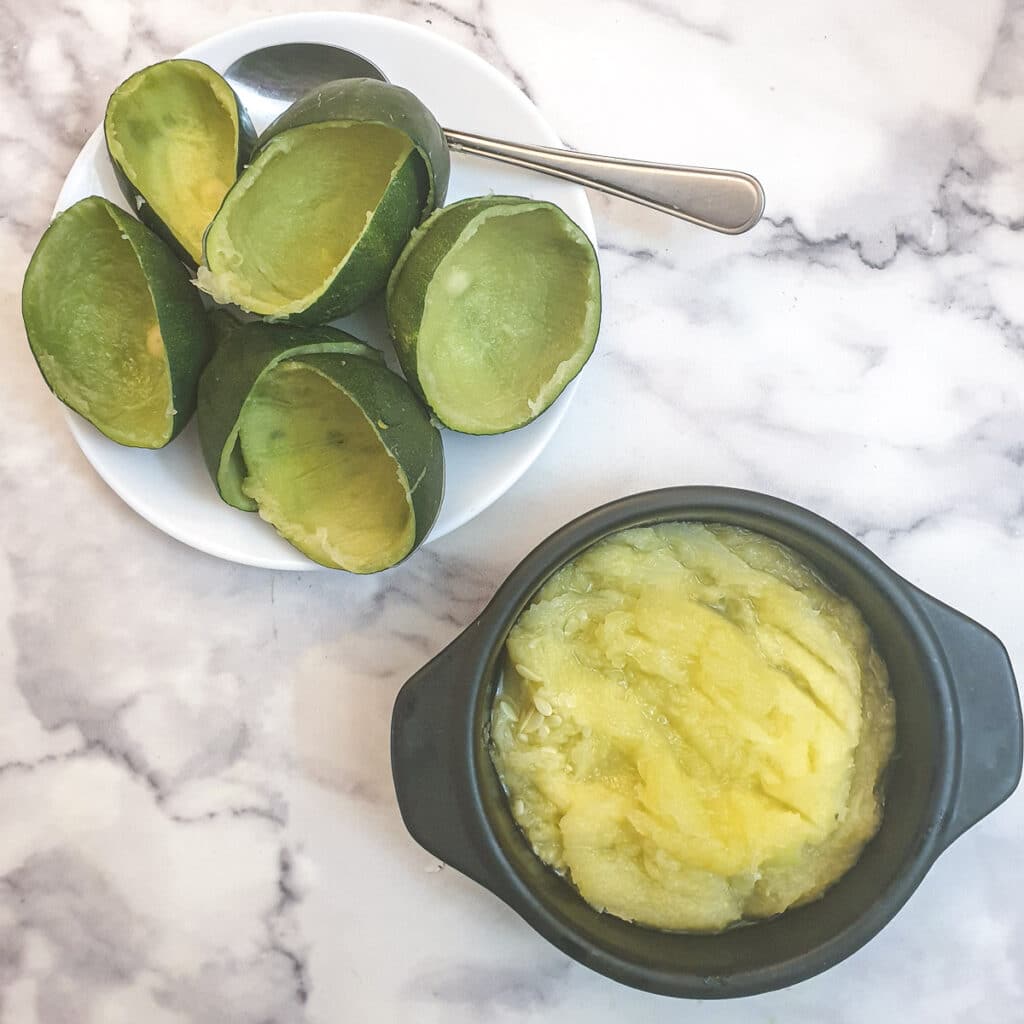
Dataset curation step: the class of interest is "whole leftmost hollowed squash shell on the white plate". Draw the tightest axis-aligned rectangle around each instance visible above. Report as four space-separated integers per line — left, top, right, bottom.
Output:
22 196 209 449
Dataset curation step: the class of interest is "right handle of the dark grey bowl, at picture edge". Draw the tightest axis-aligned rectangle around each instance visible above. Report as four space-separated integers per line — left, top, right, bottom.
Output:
919 592 1022 846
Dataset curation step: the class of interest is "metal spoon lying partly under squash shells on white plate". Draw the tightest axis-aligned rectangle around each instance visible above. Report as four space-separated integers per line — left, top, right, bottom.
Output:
224 43 765 234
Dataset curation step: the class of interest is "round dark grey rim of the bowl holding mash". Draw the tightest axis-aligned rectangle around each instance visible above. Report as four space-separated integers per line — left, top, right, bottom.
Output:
460 486 963 998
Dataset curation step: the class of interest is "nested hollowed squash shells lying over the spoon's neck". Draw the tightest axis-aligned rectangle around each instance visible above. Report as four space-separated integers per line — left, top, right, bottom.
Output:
198 79 449 324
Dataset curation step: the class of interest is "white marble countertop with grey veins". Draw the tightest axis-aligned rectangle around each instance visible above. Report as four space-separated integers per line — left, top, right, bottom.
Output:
0 0 1024 1024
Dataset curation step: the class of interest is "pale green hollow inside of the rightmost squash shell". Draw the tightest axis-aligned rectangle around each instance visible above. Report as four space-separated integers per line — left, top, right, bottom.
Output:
417 206 600 433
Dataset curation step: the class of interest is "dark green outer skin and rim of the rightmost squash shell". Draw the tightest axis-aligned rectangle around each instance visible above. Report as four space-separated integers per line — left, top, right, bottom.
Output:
386 196 600 433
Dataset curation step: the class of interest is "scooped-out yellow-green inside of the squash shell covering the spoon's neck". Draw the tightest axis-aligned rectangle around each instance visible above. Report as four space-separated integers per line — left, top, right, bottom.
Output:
200 122 413 316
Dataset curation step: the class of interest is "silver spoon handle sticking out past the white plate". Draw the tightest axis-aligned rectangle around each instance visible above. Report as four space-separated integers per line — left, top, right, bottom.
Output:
444 128 765 234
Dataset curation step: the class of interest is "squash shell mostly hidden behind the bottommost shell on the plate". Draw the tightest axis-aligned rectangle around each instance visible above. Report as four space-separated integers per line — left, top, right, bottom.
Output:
199 311 382 512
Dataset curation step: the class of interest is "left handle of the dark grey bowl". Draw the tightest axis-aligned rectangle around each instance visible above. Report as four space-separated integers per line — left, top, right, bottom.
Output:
391 628 494 890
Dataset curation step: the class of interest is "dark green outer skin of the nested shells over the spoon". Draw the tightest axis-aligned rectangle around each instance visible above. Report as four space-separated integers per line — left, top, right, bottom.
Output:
204 79 451 325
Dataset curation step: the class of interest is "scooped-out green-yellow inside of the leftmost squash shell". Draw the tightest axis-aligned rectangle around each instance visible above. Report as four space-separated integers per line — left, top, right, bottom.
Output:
32 206 174 447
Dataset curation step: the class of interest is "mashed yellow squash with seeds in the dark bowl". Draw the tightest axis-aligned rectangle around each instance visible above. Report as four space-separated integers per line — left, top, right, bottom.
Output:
490 523 894 931
